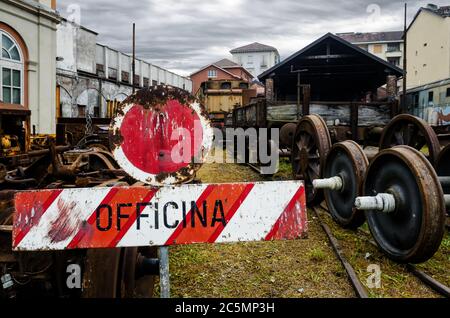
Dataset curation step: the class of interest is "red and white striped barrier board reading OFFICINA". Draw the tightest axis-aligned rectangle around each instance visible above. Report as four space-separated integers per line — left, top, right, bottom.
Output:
13 181 307 251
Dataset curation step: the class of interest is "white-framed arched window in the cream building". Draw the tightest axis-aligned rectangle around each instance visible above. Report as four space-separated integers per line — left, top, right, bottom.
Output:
0 29 24 105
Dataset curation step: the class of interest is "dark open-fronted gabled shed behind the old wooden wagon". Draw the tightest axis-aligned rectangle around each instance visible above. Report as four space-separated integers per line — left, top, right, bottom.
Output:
258 33 403 101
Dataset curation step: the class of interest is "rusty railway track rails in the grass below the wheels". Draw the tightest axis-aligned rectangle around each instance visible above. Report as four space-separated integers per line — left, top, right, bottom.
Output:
312 205 450 298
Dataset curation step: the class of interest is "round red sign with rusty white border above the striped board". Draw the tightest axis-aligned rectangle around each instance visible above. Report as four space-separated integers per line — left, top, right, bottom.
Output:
109 85 213 186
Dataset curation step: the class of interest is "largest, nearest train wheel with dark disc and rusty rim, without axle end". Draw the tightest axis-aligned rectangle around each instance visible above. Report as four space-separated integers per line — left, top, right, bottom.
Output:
363 146 445 263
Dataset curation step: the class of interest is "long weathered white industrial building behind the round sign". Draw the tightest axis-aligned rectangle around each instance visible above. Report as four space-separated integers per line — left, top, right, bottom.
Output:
56 20 192 118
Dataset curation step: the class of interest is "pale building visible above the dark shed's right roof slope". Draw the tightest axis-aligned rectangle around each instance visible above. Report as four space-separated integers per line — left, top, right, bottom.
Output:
336 31 404 68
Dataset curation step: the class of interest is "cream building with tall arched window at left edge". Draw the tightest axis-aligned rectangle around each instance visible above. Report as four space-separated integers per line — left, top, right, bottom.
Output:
0 0 60 133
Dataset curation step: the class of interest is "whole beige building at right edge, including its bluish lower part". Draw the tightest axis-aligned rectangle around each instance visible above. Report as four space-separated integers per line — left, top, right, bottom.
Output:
406 4 450 125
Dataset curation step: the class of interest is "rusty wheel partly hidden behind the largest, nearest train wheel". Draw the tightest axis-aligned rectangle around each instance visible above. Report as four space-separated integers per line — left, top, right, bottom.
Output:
380 114 441 166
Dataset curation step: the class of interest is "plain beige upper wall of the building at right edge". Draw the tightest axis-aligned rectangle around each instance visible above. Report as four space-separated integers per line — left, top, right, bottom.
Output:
406 5 450 89
